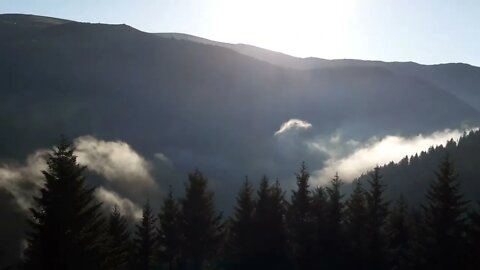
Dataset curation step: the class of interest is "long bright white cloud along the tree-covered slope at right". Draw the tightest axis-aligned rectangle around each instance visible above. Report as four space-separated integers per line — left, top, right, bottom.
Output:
311 129 472 184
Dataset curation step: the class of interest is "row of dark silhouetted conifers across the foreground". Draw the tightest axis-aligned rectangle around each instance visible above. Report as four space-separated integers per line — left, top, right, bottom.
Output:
2 139 480 270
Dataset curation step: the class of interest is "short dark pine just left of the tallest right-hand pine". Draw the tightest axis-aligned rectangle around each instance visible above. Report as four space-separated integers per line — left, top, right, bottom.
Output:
387 196 413 269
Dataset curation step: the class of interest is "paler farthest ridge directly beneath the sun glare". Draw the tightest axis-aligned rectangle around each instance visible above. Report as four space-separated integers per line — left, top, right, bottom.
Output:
157 33 480 110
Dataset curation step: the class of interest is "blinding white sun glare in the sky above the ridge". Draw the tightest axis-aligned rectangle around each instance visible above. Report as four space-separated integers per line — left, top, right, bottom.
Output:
211 0 355 58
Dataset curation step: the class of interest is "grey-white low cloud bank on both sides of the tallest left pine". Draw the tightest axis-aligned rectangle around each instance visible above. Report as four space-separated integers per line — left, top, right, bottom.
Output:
0 136 158 214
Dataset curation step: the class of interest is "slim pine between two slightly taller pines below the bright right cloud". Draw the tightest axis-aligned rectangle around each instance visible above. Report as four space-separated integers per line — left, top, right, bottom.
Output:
345 180 367 270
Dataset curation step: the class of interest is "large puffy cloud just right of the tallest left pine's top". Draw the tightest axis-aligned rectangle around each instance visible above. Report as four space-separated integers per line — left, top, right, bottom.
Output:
75 136 155 188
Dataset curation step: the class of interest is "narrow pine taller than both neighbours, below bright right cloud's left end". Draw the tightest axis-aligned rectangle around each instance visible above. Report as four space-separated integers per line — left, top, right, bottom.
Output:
325 173 345 269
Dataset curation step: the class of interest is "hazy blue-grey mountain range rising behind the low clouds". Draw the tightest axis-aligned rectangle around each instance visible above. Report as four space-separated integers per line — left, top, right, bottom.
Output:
0 14 480 201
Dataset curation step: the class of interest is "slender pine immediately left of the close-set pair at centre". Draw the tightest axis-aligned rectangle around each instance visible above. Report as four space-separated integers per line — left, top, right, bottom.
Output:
229 178 255 269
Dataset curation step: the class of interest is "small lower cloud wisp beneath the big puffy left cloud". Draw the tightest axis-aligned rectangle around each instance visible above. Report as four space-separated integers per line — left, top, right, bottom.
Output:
95 187 142 219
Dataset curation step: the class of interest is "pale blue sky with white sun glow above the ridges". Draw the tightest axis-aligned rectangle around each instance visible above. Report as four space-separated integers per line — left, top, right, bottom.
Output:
0 0 480 66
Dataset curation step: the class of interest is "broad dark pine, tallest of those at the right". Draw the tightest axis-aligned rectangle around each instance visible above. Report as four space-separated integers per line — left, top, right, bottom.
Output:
422 156 467 270
